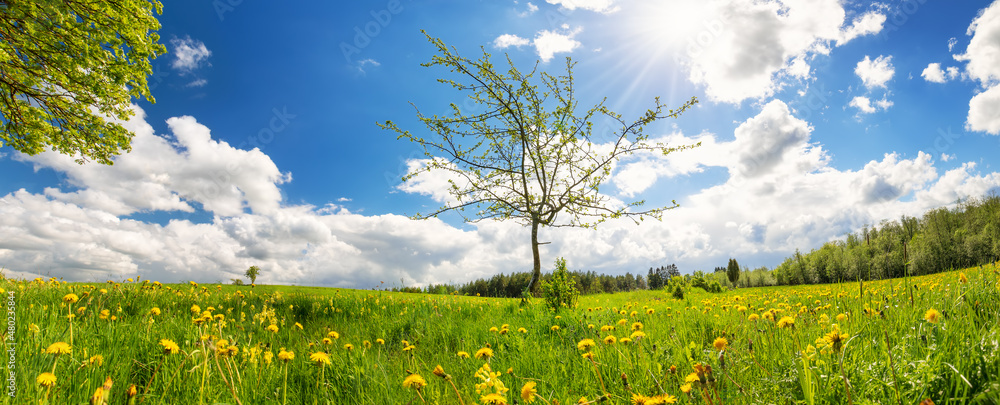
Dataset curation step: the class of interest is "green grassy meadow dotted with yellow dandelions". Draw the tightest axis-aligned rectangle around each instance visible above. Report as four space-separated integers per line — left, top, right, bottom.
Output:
0 264 1000 405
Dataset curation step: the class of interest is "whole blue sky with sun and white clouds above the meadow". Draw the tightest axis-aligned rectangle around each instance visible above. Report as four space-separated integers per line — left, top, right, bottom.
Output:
0 0 1000 288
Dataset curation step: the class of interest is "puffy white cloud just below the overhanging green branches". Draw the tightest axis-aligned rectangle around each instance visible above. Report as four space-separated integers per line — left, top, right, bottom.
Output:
15 106 291 216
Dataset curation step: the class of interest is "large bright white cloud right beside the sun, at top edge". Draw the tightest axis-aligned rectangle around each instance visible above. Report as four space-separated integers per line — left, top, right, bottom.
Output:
682 0 885 103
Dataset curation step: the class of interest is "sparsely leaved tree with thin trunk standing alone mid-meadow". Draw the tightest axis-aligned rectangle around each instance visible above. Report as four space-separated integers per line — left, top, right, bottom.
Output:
378 32 698 293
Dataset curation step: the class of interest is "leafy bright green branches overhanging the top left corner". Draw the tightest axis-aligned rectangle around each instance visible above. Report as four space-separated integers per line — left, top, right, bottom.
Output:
0 0 167 164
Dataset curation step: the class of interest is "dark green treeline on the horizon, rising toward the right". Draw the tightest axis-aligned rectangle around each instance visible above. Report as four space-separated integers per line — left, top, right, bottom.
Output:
393 194 1000 297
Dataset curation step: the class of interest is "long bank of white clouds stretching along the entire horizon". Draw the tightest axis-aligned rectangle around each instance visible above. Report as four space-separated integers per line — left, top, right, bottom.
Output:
0 100 1000 288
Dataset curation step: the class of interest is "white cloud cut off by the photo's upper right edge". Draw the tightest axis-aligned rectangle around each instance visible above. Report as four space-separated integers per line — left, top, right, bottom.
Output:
955 2 1000 135
